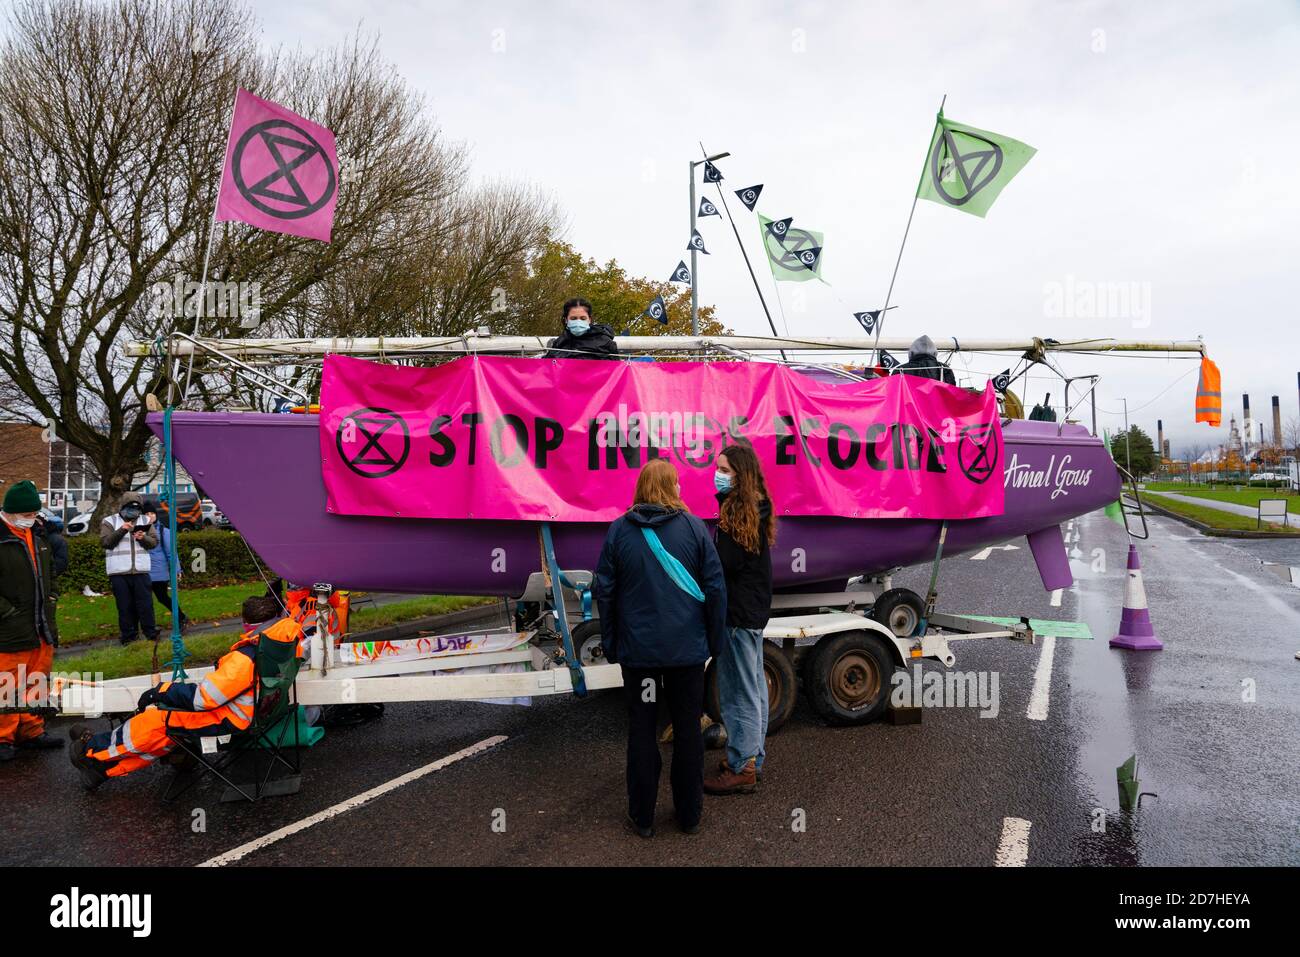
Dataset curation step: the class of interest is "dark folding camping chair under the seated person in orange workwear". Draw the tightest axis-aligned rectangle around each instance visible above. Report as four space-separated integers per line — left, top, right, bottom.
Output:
163 635 302 801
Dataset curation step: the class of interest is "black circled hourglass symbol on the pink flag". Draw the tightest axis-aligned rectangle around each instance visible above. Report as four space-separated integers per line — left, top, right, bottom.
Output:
231 120 338 220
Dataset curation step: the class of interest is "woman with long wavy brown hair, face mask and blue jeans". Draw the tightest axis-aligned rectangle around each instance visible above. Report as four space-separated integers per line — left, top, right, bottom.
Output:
705 445 776 794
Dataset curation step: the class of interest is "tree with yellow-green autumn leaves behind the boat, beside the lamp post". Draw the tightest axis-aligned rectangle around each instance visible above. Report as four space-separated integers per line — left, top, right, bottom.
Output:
499 241 728 337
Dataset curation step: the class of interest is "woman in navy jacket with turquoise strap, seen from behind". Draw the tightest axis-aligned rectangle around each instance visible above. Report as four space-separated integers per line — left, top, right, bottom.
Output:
593 459 727 837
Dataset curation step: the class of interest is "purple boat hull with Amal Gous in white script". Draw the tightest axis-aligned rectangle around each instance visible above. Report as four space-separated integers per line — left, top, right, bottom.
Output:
150 412 1119 596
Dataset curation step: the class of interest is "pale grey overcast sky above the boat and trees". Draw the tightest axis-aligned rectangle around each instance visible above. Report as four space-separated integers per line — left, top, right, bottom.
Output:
255 0 1300 452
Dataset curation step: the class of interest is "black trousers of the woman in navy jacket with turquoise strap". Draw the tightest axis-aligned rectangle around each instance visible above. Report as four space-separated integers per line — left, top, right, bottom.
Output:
621 664 705 827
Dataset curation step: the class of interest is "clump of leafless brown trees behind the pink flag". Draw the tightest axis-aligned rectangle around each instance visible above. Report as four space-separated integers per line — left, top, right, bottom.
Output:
0 0 554 520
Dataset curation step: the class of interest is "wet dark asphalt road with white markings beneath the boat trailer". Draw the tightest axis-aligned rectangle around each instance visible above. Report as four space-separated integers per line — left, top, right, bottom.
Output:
0 514 1300 866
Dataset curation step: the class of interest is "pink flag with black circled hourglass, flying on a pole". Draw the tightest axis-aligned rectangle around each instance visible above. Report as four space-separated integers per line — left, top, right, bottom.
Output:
217 90 338 242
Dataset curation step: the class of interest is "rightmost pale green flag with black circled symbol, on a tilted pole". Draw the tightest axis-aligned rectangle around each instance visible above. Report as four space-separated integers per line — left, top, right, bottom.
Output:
917 113 1037 217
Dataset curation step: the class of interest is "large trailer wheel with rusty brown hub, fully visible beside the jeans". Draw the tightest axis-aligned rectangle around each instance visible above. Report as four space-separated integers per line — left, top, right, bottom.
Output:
803 631 894 724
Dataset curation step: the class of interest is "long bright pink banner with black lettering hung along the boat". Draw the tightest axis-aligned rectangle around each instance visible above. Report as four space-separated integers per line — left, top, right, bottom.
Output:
320 356 1002 521
